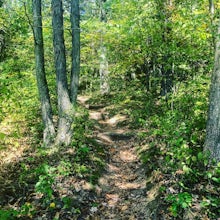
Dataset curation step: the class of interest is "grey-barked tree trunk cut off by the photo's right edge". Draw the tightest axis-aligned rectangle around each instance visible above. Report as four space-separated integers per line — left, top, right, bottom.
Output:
204 22 220 162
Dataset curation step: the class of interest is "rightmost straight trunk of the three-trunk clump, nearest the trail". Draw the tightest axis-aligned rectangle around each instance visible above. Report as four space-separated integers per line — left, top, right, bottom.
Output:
70 0 80 104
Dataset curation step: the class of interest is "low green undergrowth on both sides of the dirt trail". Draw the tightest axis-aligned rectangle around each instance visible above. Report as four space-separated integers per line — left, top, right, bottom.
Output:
0 53 220 220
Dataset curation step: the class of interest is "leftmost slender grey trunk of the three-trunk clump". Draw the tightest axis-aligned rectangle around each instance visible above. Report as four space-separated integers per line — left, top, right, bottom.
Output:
32 0 55 145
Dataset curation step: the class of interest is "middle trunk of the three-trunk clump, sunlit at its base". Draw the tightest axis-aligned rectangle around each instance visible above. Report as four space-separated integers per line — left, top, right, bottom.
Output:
52 0 73 145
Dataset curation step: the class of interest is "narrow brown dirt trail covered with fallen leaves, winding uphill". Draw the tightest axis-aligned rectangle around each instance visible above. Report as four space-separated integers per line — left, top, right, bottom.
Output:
79 96 158 220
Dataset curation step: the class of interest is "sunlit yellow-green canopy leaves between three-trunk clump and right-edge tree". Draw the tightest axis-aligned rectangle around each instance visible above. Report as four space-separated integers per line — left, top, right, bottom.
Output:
81 0 213 93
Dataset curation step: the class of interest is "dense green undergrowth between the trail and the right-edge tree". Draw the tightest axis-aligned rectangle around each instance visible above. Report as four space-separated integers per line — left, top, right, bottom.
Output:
88 75 220 219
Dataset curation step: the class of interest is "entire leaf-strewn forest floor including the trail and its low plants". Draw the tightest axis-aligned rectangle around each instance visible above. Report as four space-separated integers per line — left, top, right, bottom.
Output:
0 92 220 220
